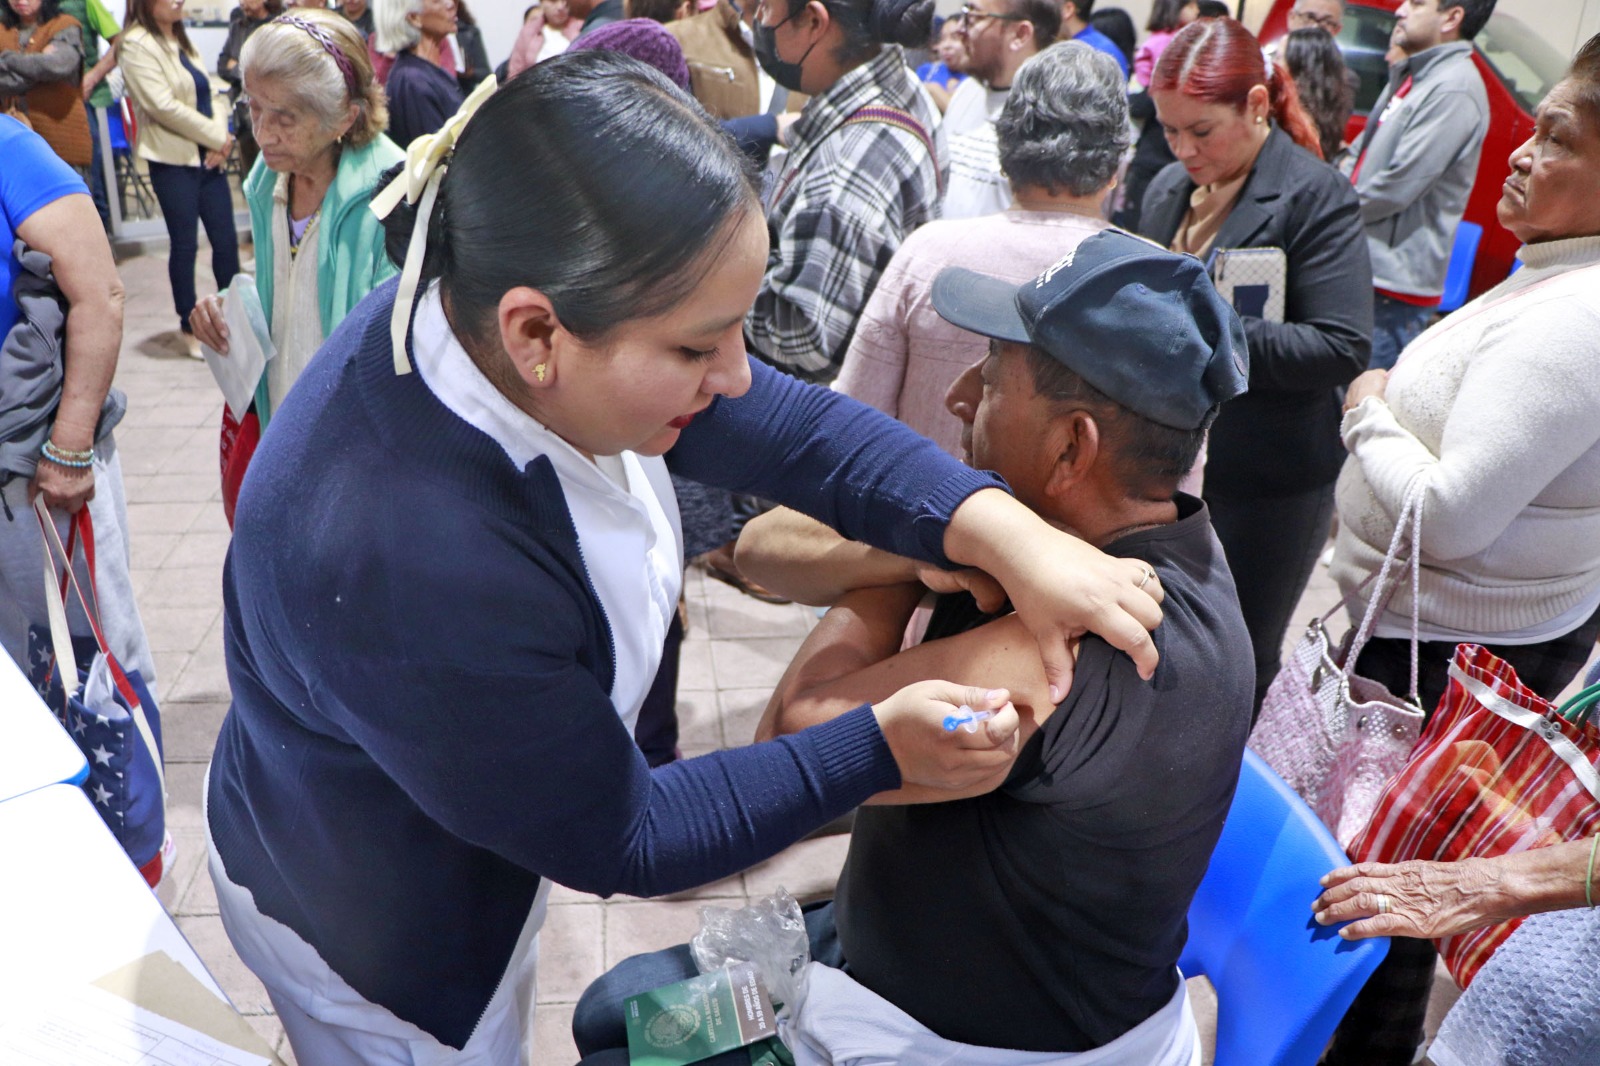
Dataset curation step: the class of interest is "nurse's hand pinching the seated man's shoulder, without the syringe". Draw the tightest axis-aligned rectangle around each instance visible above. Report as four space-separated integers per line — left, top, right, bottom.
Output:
944 488 1165 703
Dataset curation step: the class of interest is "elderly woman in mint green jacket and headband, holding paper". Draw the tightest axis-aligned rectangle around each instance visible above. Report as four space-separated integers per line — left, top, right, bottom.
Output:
190 8 403 432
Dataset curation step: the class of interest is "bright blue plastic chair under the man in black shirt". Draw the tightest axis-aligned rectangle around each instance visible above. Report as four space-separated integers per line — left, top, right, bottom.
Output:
1178 752 1389 1066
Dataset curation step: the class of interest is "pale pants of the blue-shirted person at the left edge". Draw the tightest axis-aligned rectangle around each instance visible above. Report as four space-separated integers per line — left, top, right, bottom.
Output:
0 437 158 698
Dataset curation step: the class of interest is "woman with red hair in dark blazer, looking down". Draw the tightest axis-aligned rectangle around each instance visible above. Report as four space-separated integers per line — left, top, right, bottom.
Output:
1139 12 1373 707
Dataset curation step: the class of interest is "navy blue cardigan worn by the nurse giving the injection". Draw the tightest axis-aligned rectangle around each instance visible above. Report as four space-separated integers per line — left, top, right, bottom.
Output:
208 282 998 1047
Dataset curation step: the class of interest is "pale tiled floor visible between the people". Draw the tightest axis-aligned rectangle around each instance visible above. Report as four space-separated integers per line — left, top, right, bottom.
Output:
106 246 1472 1066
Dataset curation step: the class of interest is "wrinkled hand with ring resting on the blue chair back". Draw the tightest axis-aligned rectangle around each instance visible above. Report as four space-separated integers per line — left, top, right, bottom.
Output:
1310 858 1518 940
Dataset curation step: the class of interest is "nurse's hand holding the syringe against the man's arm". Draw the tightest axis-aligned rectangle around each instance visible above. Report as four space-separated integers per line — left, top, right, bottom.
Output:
872 680 1021 799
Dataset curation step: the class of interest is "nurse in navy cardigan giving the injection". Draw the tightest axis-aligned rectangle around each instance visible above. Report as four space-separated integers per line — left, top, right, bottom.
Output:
206 51 1160 1066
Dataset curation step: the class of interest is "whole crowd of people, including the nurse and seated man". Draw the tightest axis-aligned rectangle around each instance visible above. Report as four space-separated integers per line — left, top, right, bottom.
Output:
0 0 1600 1066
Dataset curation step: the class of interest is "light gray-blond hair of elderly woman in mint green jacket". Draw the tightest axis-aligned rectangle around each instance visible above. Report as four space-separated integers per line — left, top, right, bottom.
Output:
238 8 389 147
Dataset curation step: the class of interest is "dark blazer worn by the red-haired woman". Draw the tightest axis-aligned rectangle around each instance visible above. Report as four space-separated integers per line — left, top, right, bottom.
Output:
1139 126 1373 498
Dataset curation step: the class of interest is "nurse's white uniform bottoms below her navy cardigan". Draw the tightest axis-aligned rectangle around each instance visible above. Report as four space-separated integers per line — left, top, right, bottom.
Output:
203 770 550 1066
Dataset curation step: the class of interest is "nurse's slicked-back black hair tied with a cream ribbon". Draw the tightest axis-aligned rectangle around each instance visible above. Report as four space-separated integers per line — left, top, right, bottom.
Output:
384 50 760 352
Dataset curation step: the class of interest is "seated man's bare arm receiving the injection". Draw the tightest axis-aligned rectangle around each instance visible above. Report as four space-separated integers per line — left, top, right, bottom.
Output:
755 584 1077 804
